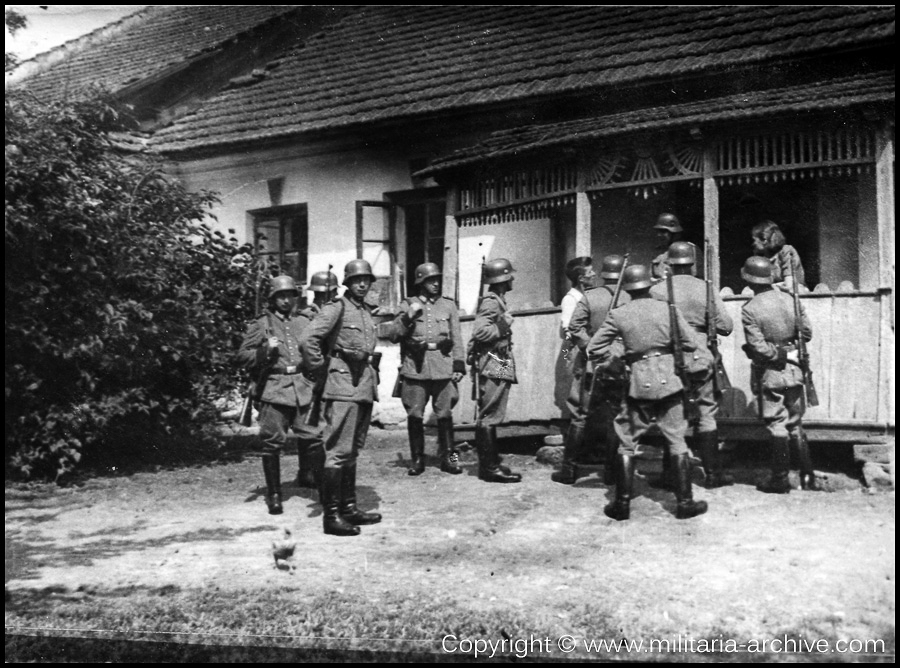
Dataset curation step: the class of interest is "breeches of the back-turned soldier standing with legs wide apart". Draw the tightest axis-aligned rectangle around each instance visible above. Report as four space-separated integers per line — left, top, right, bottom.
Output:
615 392 688 455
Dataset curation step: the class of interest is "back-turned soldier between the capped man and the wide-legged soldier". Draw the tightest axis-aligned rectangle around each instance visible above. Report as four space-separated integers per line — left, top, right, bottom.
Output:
550 255 630 485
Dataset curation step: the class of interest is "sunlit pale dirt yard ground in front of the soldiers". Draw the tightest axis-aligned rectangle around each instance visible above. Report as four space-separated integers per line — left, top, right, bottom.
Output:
6 428 895 661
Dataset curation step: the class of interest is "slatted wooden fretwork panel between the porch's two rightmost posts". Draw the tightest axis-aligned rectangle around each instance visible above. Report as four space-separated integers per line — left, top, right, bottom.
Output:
714 128 875 184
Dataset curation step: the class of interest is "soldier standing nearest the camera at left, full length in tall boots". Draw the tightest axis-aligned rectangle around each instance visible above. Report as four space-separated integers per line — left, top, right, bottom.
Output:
301 260 381 536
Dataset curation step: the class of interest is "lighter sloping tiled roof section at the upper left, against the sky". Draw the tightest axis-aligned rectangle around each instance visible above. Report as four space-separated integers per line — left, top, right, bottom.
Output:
14 5 296 102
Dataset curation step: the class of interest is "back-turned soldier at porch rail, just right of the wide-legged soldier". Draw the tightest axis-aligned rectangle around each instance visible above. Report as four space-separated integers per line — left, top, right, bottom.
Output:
650 241 734 489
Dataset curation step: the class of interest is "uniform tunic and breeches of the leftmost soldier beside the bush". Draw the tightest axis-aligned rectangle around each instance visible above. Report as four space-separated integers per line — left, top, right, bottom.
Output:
237 308 322 453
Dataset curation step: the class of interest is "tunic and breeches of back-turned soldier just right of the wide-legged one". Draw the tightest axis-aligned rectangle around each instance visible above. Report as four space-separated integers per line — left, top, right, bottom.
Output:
650 274 734 433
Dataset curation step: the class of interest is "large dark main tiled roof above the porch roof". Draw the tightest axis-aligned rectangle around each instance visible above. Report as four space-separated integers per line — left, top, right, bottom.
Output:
154 5 894 152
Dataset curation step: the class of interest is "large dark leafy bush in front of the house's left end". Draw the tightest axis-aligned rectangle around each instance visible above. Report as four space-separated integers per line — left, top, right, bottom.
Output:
5 91 254 478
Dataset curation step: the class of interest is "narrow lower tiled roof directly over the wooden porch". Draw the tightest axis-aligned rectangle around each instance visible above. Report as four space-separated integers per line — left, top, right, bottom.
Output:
416 71 895 176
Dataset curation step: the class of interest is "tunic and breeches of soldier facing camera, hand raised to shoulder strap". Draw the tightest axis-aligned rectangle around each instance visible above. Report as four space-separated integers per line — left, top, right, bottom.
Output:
386 296 466 420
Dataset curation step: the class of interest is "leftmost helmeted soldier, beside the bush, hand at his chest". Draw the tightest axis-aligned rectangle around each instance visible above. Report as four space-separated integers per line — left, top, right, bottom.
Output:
237 276 323 515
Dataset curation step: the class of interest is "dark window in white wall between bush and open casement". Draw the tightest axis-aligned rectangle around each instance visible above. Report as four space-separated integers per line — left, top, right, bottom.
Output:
248 204 309 283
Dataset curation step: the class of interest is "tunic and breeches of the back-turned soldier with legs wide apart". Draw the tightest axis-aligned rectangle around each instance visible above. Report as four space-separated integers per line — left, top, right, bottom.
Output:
587 296 697 455
